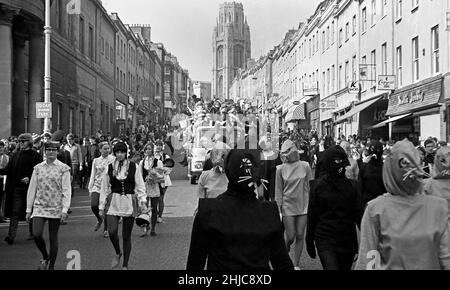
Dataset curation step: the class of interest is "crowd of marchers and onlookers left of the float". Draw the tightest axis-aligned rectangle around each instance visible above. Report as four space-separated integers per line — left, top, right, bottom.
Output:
0 127 175 270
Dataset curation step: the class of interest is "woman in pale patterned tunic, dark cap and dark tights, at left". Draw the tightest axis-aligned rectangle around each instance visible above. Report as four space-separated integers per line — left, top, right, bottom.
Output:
26 142 72 270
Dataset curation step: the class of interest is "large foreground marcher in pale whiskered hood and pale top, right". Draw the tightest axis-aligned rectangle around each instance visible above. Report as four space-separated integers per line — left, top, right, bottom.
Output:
356 140 450 270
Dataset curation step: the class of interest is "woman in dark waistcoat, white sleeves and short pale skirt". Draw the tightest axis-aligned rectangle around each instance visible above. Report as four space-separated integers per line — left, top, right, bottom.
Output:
99 142 147 270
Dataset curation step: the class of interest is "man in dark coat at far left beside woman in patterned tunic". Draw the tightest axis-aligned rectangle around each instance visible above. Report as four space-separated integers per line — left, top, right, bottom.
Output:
0 134 42 245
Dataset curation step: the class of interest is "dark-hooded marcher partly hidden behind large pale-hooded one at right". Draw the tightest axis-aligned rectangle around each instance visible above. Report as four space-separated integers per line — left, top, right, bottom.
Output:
358 141 386 204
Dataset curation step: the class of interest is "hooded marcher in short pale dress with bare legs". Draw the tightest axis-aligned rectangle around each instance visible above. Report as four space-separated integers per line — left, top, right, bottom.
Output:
275 140 312 270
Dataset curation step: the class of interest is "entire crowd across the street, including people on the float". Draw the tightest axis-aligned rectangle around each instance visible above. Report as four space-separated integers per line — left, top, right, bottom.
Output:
0 93 450 270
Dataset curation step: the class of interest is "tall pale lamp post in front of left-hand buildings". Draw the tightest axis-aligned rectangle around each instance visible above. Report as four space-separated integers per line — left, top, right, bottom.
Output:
44 0 52 133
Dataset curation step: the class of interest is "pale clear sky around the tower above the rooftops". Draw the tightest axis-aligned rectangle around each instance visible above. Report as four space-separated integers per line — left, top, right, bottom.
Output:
102 0 320 82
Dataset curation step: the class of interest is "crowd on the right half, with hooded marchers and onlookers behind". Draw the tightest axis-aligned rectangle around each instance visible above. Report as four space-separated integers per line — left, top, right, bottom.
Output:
183 96 450 270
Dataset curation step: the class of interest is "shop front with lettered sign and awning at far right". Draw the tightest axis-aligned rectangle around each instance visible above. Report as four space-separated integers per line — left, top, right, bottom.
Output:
373 76 445 142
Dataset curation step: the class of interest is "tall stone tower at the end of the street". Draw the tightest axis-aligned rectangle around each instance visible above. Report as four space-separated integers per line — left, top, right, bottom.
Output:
212 2 251 99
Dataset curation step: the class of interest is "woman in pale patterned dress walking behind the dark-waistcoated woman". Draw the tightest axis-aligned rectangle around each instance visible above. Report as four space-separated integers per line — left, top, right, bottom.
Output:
88 142 116 238
